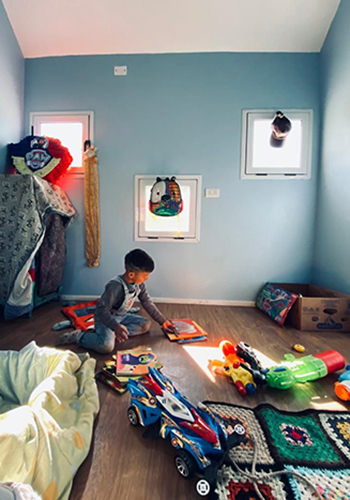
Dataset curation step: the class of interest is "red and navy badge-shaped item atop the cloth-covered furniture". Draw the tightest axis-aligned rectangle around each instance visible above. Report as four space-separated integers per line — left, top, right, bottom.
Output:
8 135 73 183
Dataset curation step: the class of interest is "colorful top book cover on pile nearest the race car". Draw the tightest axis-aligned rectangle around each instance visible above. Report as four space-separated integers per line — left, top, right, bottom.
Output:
116 348 163 377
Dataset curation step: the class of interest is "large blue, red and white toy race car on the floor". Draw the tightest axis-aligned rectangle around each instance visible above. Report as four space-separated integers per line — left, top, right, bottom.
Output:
128 368 246 496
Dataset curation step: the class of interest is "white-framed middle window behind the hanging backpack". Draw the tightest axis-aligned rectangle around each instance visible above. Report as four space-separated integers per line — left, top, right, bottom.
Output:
135 175 202 242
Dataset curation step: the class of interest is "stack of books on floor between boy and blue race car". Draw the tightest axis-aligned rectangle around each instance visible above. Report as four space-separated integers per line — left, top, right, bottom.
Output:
96 347 163 394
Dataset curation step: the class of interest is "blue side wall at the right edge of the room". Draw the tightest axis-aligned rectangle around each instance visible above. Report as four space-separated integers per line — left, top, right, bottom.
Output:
314 1 350 293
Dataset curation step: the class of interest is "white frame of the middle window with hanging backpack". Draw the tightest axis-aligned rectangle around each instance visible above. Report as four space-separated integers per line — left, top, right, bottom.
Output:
134 174 202 243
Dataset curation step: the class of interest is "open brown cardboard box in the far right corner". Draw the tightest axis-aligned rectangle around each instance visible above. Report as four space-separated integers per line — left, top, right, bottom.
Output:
274 283 350 332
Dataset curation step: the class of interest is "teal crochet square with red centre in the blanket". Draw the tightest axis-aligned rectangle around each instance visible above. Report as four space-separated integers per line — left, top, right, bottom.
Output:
258 407 344 467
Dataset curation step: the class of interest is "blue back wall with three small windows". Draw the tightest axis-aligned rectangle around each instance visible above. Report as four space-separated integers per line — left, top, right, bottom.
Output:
25 53 320 300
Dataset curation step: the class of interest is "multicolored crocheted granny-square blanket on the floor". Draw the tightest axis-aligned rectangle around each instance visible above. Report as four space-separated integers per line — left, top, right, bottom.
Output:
206 402 350 500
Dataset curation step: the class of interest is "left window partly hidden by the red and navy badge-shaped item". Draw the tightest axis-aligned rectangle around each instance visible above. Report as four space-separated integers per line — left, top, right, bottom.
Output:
30 111 94 176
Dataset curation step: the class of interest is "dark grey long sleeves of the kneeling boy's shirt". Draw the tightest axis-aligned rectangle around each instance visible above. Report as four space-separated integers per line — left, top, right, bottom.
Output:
95 280 166 330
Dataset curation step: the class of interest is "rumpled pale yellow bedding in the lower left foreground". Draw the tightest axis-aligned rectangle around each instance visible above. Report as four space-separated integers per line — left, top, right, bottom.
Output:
0 342 99 500
